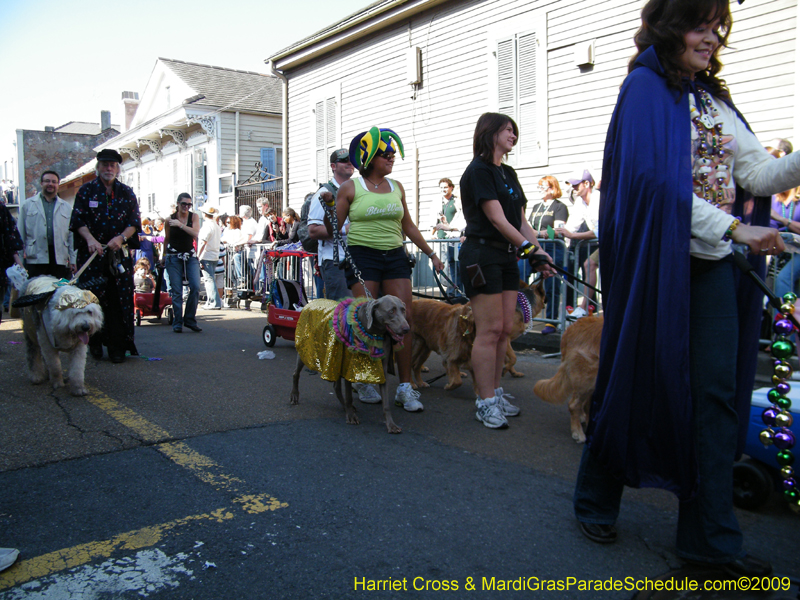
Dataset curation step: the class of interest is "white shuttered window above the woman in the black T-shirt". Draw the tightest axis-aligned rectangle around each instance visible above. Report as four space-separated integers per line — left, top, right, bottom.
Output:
489 13 548 167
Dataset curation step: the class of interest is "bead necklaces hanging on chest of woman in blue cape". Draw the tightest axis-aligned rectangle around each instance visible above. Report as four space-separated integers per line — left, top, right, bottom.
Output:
689 90 728 206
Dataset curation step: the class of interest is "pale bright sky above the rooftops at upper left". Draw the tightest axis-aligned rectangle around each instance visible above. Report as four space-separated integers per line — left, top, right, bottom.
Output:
0 0 374 179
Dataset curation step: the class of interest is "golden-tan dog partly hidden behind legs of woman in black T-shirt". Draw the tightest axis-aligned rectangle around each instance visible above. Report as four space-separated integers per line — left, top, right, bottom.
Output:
411 282 545 390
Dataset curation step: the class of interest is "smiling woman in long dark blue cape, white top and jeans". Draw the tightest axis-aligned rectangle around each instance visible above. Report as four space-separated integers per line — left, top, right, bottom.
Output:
574 0 800 577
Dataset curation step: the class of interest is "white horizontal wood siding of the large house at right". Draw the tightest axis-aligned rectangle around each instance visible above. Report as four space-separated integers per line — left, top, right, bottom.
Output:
286 0 797 226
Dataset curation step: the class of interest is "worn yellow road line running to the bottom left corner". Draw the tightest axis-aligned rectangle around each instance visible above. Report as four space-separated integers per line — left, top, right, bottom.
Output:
0 508 234 590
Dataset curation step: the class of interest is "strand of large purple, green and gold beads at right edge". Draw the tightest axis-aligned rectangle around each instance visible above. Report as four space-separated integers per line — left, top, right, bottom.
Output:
759 292 800 513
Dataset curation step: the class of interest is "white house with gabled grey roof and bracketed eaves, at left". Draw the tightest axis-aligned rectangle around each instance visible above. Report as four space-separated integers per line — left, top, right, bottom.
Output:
92 58 283 216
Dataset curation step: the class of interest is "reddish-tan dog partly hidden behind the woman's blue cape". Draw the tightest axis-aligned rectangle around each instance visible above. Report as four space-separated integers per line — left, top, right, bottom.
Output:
533 317 603 444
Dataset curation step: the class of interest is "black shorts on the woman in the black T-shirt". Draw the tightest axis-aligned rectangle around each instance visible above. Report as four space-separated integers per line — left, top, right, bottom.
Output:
458 240 519 298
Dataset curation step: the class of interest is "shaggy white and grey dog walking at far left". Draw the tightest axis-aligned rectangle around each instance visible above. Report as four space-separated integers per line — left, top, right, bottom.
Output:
20 275 103 396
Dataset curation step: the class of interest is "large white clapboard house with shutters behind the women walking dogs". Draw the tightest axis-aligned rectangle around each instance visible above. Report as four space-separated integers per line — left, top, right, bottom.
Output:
268 0 800 231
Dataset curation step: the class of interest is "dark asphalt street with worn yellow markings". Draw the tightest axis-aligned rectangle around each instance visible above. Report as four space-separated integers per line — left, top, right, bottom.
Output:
0 304 800 600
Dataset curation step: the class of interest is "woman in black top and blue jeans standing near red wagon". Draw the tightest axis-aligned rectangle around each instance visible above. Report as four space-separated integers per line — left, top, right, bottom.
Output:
164 193 203 333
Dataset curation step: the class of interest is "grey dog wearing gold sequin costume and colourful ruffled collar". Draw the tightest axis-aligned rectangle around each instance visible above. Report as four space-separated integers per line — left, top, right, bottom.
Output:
290 296 409 433
